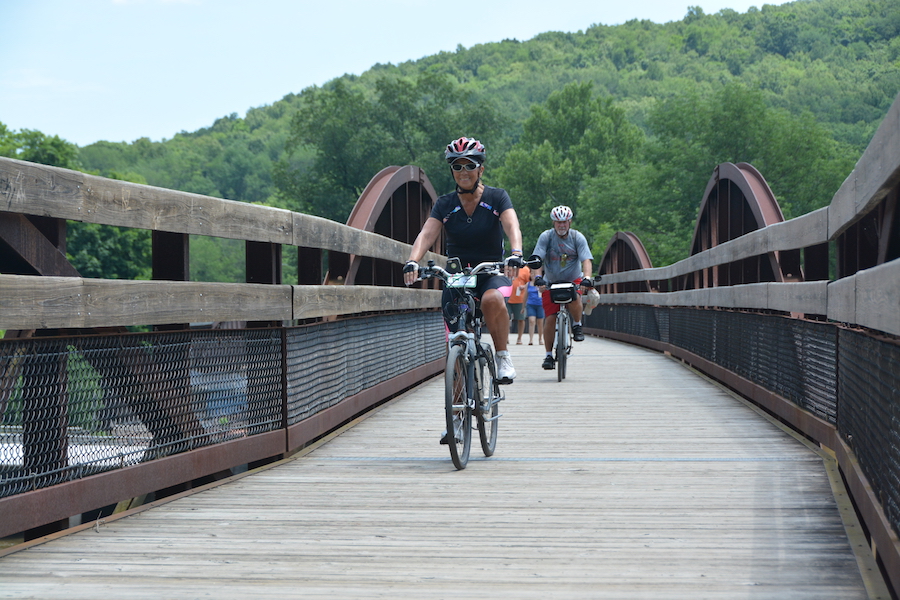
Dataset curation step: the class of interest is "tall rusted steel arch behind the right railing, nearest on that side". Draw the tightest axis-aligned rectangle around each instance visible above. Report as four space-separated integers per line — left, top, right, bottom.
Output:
676 163 803 289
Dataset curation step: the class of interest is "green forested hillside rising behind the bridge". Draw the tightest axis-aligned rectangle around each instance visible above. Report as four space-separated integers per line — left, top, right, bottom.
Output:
7 0 900 278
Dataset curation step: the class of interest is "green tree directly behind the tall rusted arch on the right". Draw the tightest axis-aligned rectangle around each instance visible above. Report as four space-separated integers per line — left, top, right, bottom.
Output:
582 83 853 266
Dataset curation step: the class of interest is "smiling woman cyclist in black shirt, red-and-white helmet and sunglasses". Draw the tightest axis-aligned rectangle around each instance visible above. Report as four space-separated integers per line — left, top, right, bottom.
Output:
403 137 525 384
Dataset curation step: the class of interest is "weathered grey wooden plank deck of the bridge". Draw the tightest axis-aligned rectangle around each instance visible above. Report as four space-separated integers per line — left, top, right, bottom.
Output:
0 338 888 600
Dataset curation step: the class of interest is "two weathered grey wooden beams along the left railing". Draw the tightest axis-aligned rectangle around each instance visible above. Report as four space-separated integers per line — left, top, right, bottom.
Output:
0 158 443 329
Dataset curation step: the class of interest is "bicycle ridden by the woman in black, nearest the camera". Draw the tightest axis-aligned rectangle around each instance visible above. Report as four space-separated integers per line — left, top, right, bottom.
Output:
418 257 540 470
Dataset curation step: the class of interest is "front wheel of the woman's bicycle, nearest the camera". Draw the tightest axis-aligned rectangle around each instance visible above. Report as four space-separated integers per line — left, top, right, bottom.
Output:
444 345 474 469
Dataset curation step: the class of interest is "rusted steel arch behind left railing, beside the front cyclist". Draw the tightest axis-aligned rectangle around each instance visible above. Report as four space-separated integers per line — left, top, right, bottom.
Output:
325 165 444 287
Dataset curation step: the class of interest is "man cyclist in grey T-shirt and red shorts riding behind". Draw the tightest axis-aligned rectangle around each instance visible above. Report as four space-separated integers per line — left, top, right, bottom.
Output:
533 206 594 371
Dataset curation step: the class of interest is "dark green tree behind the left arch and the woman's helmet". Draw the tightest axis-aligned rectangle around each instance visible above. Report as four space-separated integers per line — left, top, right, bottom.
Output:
275 71 502 221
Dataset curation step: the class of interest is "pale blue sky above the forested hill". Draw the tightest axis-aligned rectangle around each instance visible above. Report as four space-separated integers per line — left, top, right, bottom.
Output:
0 0 784 146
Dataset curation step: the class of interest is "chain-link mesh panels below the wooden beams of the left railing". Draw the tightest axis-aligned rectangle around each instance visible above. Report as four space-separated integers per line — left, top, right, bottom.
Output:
0 312 446 498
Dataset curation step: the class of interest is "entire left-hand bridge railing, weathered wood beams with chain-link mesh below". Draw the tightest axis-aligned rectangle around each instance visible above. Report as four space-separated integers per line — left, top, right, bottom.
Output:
0 158 445 537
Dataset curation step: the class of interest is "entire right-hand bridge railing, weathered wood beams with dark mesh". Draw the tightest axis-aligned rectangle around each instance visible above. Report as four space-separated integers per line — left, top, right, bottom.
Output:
586 90 900 589
